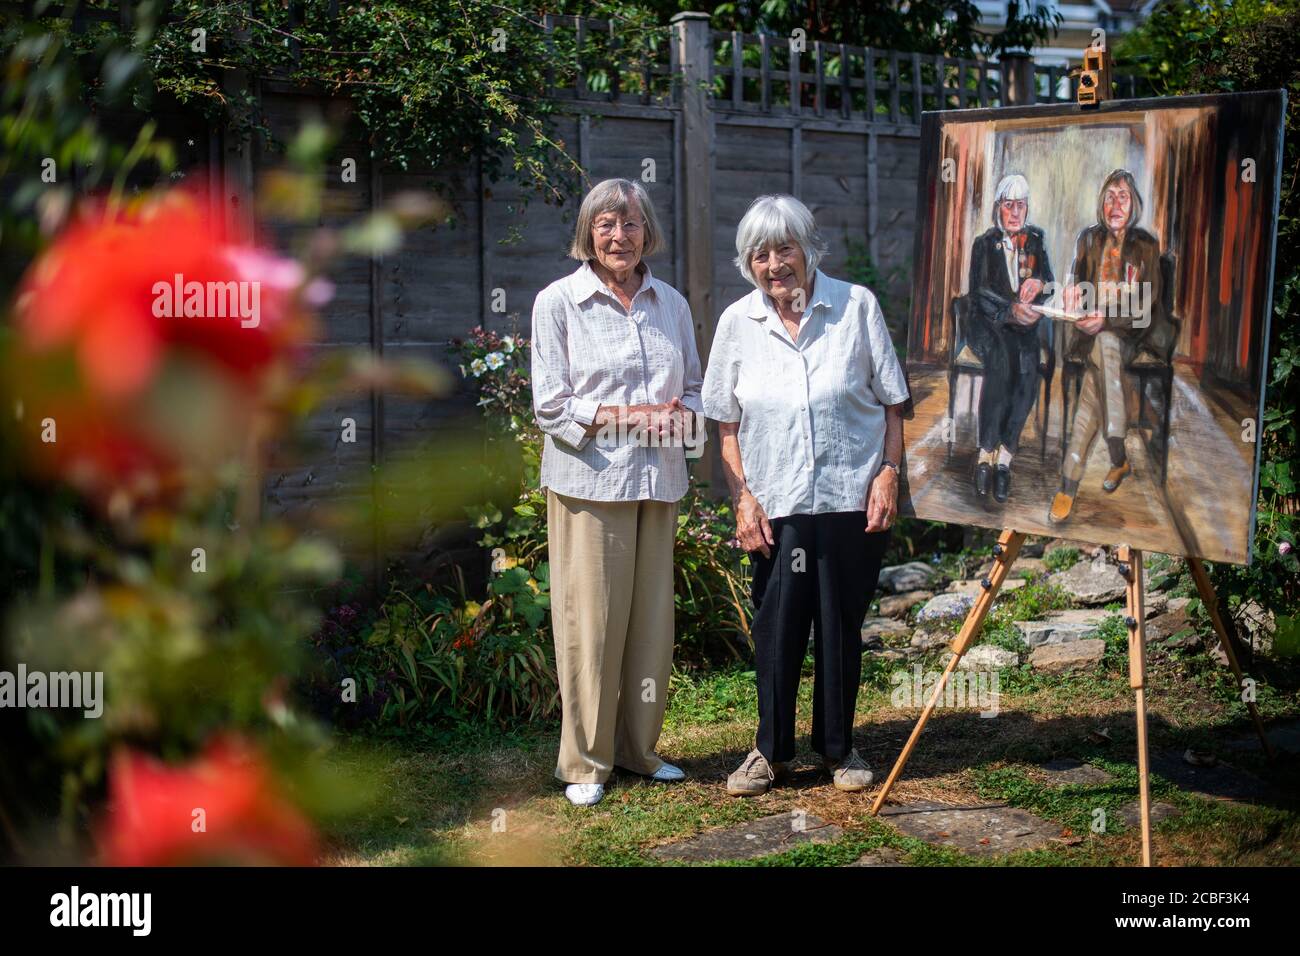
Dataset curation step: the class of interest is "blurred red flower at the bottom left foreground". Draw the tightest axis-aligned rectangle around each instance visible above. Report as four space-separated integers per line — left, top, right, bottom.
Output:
99 737 317 866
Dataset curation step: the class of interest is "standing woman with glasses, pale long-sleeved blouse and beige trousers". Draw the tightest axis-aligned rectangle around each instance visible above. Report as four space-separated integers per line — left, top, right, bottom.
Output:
532 179 703 805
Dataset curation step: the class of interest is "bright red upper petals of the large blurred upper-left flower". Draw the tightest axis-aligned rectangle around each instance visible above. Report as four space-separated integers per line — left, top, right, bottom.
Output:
17 190 312 397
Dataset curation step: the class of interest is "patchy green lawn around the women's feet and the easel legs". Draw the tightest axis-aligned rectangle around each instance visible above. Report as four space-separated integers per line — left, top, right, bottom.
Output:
317 632 1300 866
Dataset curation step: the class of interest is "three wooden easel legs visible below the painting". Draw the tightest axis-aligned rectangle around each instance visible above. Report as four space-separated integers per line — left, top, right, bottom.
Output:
871 531 1274 866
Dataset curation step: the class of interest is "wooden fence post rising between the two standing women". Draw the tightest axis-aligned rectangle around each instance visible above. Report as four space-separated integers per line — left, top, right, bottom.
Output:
668 12 725 494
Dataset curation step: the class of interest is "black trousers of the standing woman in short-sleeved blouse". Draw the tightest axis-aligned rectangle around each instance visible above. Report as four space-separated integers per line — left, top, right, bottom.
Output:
750 511 889 762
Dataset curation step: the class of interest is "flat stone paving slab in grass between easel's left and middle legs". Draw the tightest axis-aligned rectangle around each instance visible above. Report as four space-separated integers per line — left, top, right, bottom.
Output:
880 800 1061 856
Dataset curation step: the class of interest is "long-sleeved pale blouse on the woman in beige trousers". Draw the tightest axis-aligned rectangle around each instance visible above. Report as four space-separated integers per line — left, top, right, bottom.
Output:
532 263 703 501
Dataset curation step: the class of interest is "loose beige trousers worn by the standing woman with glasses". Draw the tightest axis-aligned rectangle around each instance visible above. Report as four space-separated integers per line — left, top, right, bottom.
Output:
546 489 677 783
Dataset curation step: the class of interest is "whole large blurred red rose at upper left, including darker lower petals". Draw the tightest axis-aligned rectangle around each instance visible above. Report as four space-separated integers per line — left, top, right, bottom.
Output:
7 189 321 506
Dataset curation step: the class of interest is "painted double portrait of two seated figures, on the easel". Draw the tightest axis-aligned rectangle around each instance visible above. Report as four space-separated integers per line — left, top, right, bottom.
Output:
901 91 1283 563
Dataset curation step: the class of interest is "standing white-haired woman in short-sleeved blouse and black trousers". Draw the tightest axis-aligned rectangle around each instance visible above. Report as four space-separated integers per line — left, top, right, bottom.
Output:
703 195 907 796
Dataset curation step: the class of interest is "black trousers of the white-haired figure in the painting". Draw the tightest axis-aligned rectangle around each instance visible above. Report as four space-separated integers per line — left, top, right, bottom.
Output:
979 325 1039 453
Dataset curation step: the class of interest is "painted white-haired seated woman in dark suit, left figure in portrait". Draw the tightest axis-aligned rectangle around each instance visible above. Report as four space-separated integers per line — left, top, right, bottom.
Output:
966 173 1052 503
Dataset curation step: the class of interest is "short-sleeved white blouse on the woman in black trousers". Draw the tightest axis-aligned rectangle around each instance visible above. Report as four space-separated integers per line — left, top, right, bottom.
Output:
703 269 907 518
